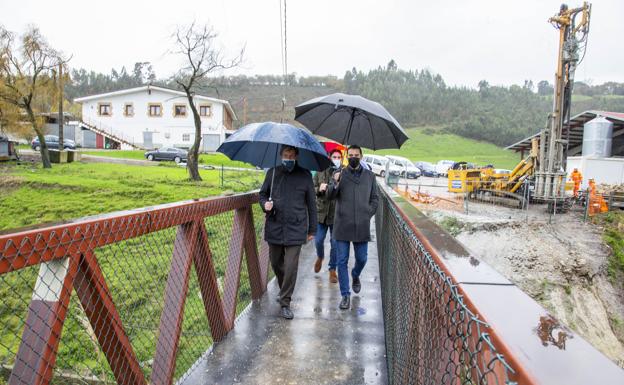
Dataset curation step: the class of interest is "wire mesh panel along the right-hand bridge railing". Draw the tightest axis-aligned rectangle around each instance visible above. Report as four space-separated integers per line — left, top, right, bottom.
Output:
376 189 513 384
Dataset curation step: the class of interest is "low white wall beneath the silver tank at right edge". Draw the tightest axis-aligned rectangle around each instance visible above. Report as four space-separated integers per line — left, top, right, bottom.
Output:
566 156 624 189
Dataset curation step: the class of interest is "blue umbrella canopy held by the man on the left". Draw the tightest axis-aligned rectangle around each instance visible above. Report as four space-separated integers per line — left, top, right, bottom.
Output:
217 122 331 171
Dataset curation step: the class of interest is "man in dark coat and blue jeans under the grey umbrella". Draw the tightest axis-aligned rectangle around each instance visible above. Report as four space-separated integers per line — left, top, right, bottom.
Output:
328 145 379 309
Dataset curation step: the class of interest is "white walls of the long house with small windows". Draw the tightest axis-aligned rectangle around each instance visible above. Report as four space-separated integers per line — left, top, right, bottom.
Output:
82 90 225 148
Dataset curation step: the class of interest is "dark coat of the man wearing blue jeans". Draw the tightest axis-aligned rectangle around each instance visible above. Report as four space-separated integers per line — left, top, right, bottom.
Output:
328 167 379 242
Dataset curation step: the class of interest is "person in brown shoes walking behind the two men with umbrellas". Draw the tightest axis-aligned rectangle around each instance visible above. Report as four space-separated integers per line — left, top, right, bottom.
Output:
314 149 342 283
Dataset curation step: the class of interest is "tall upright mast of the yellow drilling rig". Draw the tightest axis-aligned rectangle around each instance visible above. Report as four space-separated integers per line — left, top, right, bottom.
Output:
533 2 591 208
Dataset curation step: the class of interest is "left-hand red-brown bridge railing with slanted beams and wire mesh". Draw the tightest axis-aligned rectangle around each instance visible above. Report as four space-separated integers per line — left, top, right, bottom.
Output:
0 193 268 384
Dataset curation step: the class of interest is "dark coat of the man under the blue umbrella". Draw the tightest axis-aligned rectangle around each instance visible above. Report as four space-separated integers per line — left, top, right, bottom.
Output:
260 165 317 246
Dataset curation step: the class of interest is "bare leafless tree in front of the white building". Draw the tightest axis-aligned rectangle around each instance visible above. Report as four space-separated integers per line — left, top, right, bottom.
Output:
173 23 245 180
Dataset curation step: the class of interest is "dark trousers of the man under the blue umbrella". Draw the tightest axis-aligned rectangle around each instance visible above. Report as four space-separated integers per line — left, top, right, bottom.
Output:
269 243 301 306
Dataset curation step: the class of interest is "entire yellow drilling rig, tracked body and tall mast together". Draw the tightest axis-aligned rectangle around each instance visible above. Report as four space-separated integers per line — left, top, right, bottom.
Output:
448 2 591 211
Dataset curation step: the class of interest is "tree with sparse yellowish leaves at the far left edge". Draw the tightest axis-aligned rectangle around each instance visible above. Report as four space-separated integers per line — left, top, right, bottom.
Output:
0 26 58 168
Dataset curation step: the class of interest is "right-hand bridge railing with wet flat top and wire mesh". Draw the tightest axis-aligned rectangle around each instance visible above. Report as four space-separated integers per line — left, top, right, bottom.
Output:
375 184 624 385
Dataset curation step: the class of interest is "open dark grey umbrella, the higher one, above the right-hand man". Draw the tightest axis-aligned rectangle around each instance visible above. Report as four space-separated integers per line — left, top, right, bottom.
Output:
295 93 408 150
